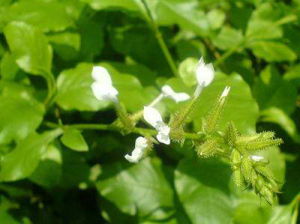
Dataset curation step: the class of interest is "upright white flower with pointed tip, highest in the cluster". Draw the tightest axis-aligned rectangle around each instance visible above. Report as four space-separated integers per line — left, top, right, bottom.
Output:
196 57 215 87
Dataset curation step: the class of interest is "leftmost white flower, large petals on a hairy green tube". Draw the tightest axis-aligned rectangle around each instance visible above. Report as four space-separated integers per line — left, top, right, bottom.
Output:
91 66 118 102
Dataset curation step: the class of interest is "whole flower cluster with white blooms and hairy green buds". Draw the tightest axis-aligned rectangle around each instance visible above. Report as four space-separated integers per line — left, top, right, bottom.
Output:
91 58 282 203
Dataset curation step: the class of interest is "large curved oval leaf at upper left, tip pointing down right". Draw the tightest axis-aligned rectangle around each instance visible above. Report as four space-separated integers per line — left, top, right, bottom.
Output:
4 22 52 78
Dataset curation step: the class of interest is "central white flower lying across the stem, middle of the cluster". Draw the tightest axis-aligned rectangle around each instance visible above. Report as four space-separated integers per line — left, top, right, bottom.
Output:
144 107 171 145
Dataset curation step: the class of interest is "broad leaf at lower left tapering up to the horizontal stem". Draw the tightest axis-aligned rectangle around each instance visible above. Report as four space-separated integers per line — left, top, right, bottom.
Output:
0 129 62 181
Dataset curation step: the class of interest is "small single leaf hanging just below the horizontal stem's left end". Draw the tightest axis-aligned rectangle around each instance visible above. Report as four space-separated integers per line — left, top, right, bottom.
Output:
61 128 88 152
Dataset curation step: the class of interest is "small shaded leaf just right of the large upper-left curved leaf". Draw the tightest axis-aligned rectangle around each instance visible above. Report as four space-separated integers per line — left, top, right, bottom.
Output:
48 32 80 60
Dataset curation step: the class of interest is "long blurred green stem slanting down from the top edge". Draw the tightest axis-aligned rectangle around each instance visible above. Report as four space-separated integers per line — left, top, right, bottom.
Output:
142 0 179 77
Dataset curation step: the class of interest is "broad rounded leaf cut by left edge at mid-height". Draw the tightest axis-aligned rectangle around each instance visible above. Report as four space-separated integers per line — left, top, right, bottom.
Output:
0 83 44 144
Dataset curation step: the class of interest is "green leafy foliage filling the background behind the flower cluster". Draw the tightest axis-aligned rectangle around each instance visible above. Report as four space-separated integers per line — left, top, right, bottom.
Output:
0 0 300 224
